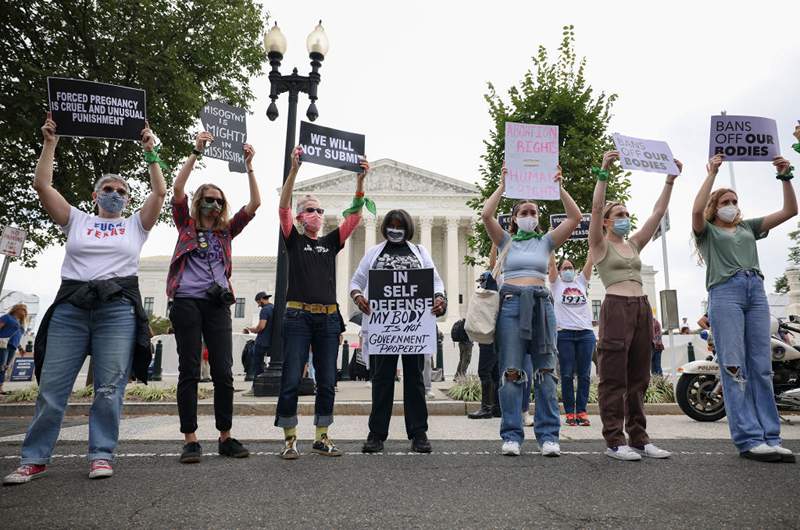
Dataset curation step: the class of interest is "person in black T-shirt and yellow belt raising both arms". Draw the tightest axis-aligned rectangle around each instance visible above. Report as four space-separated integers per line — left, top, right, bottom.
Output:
275 147 374 460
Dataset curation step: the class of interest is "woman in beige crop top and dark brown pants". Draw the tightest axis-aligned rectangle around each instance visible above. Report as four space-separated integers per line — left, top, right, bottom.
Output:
589 151 683 460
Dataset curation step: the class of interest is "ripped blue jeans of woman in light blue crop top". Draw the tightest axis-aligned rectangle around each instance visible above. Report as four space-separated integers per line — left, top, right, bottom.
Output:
495 286 561 444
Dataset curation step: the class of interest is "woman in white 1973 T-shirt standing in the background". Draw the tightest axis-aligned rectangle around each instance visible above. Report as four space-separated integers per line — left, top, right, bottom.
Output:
549 255 595 427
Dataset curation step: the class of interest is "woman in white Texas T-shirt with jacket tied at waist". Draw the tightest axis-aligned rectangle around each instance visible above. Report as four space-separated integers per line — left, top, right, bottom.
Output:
3 113 167 484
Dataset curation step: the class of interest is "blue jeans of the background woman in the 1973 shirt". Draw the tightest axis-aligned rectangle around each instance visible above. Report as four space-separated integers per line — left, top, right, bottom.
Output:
558 329 596 414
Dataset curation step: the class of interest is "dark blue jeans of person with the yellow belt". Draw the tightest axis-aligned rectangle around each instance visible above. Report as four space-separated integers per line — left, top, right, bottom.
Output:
275 309 342 428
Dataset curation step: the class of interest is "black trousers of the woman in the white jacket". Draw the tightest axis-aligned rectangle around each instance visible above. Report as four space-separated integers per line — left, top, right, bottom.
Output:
369 355 428 441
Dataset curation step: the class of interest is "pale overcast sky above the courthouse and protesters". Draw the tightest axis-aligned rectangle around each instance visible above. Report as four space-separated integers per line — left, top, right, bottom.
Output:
5 0 800 326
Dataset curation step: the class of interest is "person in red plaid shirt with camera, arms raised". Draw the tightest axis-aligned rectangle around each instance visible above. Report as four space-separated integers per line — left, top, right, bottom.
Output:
167 131 261 464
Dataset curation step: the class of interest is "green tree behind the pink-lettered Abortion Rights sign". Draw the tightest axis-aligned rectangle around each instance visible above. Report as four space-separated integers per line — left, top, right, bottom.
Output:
465 26 630 267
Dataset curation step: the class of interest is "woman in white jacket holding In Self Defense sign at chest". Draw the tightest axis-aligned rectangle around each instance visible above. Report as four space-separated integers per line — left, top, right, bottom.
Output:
350 210 447 453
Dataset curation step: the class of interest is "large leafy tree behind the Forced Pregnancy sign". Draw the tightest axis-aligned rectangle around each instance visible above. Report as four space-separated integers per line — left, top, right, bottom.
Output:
0 0 265 266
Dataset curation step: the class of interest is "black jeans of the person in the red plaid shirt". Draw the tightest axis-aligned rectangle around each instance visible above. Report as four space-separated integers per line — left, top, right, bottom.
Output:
169 298 233 433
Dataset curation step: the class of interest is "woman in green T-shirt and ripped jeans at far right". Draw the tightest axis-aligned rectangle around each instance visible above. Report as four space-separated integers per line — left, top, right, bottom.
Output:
692 151 797 462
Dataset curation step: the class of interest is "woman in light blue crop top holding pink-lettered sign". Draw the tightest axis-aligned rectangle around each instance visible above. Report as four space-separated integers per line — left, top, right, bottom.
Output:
481 165 581 456
